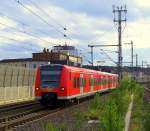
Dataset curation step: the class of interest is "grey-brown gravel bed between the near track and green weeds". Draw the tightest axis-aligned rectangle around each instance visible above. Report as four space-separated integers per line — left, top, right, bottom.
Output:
14 95 107 131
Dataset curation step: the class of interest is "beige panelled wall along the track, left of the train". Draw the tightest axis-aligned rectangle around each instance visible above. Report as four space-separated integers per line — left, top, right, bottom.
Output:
0 65 35 105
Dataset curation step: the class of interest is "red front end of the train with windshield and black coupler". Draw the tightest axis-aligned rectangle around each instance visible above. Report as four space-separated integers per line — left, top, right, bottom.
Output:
35 64 65 105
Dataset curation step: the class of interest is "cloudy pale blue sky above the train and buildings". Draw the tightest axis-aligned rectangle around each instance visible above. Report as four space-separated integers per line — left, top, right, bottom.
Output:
0 0 150 65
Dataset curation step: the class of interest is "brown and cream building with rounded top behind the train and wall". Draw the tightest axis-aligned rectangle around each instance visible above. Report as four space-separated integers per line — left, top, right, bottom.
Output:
0 45 82 68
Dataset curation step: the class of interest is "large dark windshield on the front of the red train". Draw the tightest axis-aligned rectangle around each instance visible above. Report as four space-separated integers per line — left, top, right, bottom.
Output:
41 65 62 88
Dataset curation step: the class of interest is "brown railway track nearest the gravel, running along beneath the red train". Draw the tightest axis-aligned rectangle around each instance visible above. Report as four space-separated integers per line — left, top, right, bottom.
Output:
0 93 110 131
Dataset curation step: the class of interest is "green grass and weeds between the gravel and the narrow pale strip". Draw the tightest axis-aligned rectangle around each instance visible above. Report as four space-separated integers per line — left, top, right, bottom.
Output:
74 77 146 131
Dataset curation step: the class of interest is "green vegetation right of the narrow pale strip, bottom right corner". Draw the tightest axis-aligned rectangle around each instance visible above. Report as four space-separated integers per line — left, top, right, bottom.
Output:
130 81 150 131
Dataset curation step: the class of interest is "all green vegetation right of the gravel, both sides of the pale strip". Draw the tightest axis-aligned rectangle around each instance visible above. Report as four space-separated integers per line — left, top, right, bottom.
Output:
46 77 150 131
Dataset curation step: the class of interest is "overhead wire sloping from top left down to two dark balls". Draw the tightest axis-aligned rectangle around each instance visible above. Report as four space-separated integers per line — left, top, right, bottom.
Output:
14 0 64 35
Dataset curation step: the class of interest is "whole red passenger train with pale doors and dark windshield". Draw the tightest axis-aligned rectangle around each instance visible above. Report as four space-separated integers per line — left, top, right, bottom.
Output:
35 64 118 105
